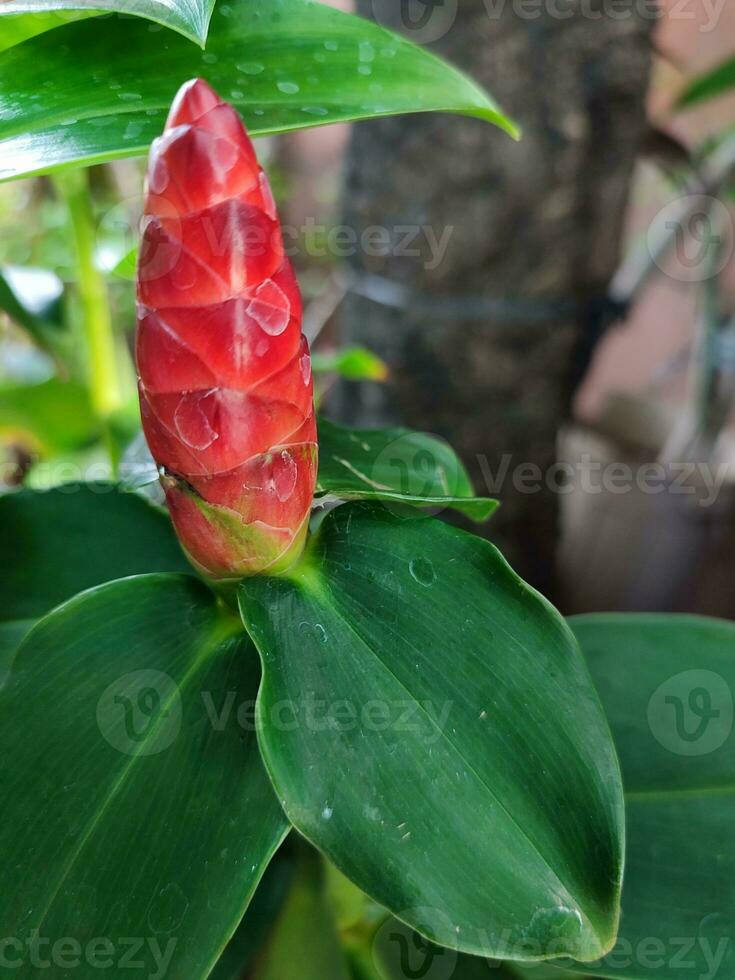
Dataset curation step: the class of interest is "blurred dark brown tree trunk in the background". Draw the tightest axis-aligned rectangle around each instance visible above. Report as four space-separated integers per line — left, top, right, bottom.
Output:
333 0 651 594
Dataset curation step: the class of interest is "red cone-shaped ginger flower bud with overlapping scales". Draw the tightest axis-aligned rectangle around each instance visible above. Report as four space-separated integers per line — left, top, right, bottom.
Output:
136 79 317 579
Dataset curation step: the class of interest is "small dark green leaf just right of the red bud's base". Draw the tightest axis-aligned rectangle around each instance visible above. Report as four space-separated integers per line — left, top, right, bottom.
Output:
317 419 498 521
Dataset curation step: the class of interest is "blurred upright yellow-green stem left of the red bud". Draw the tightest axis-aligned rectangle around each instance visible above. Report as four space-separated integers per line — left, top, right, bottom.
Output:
54 170 123 421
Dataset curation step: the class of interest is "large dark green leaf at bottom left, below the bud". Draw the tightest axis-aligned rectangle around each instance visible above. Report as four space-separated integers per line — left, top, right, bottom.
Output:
0 575 287 980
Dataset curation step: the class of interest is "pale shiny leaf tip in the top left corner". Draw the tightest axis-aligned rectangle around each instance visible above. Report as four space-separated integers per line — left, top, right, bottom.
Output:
0 0 214 47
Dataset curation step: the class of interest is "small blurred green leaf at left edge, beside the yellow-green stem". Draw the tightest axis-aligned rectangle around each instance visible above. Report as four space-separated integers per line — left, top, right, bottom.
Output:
0 378 99 453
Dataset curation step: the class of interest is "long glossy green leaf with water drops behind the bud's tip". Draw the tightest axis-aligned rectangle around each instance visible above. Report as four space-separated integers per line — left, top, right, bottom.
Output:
0 0 515 180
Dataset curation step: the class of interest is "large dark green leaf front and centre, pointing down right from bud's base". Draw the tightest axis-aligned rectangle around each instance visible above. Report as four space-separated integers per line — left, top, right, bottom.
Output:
241 503 623 960
